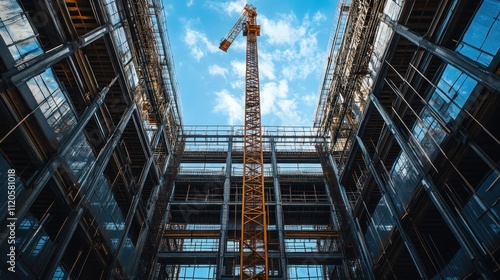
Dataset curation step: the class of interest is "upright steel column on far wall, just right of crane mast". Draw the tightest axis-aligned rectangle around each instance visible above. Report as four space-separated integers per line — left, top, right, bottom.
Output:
270 137 288 280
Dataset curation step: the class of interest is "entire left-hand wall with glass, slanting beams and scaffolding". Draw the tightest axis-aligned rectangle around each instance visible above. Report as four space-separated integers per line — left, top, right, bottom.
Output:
0 0 180 279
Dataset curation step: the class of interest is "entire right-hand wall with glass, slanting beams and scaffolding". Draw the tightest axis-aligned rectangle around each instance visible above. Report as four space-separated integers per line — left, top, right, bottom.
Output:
315 0 500 279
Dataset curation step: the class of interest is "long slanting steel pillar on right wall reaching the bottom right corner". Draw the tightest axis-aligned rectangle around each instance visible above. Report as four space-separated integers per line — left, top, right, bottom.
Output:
369 93 495 279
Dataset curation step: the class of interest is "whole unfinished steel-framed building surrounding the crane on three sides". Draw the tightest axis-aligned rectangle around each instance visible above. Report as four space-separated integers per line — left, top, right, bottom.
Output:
0 0 500 280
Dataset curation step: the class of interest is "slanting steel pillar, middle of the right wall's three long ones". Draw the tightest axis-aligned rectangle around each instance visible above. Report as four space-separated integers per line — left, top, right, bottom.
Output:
356 136 429 279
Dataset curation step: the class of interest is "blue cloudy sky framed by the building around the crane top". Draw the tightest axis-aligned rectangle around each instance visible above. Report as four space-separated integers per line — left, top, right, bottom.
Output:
165 0 337 126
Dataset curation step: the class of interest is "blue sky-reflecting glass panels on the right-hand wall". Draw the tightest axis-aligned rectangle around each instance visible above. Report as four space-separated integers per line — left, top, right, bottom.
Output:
366 1 500 270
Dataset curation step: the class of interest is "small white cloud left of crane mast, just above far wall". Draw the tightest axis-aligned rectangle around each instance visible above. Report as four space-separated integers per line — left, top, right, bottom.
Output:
214 89 244 125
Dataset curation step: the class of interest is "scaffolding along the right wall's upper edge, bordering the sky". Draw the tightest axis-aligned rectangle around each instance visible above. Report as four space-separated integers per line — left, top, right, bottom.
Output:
314 0 383 174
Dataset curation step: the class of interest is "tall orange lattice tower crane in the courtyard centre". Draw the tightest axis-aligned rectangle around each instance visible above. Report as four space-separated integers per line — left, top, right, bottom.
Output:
219 4 268 279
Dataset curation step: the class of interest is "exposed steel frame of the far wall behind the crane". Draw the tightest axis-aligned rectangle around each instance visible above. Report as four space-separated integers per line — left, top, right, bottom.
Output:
157 126 366 280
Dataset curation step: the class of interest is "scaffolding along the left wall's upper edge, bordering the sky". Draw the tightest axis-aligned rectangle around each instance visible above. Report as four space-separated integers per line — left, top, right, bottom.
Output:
128 0 182 143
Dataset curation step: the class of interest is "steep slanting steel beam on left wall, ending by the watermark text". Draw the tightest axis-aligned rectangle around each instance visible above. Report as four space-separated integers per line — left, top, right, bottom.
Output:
0 77 117 244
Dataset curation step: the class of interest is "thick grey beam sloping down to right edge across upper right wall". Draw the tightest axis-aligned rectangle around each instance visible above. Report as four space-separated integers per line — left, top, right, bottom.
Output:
382 16 500 93
